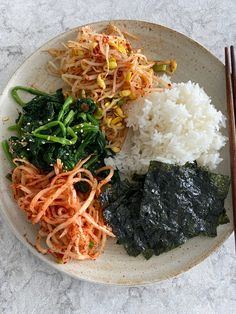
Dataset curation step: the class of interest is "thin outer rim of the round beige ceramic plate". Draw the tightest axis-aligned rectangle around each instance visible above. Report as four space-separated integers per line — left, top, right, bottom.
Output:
0 19 233 287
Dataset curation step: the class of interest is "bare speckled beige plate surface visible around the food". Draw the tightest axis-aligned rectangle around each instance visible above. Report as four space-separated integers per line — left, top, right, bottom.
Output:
0 20 233 286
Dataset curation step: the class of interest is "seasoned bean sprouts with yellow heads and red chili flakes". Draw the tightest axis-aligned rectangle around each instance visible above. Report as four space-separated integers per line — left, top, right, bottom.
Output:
48 25 170 153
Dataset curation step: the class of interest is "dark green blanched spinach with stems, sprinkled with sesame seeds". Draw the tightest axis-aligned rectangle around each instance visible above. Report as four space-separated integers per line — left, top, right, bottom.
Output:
5 86 110 171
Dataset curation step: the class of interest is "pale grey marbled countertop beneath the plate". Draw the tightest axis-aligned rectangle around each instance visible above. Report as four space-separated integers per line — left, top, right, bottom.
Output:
0 0 236 314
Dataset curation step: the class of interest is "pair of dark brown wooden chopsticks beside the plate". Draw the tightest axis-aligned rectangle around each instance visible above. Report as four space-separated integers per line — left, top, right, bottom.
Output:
225 46 236 248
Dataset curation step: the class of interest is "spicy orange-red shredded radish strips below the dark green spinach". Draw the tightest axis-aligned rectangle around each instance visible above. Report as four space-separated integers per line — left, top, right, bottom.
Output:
12 157 114 263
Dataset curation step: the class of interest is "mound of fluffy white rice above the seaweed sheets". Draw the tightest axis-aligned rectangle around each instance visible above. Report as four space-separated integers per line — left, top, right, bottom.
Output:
106 81 226 175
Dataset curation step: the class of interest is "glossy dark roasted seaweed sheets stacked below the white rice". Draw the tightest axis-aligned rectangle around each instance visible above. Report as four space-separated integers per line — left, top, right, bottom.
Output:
101 161 230 258
